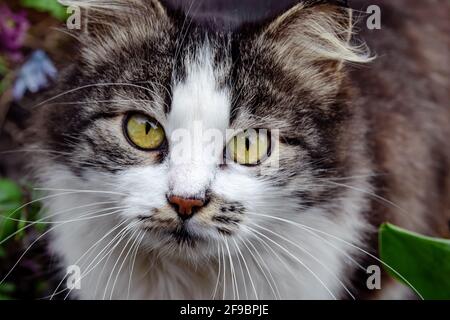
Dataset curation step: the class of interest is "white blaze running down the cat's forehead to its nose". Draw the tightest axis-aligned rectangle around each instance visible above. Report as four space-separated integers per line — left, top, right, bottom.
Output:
166 45 230 197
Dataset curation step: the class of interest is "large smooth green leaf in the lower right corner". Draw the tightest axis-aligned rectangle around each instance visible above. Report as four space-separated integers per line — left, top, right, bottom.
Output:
379 223 450 300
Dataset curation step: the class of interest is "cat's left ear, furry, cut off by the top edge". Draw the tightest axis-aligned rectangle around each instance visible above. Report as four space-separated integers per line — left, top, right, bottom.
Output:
59 0 170 67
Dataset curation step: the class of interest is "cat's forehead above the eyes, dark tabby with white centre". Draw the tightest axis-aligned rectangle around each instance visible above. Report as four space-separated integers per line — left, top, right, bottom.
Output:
77 21 300 128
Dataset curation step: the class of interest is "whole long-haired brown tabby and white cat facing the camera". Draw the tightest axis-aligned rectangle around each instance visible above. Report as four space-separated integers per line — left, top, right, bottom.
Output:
31 0 450 299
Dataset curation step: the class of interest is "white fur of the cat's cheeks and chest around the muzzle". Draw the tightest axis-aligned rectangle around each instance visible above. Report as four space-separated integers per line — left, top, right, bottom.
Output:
41 164 368 299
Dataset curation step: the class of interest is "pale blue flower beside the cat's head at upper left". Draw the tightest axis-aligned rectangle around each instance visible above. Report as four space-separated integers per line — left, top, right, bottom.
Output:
13 50 58 101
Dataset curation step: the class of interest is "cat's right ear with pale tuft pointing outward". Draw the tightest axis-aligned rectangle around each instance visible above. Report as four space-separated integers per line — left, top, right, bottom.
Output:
261 1 371 72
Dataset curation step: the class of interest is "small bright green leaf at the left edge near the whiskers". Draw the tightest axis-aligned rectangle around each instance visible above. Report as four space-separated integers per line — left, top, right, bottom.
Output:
0 179 22 242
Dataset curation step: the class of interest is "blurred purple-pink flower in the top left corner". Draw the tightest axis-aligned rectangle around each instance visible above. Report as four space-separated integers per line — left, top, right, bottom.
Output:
0 5 29 61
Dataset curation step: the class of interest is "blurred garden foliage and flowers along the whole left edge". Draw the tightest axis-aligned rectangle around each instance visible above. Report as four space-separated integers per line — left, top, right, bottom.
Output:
0 0 74 299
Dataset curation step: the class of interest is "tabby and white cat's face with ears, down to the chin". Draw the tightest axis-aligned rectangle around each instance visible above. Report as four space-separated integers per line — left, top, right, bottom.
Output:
33 1 365 259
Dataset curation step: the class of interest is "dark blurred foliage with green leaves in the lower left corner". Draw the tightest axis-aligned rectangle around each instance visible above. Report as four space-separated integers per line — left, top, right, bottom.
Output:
0 179 54 299
